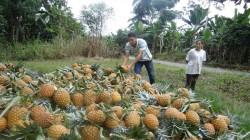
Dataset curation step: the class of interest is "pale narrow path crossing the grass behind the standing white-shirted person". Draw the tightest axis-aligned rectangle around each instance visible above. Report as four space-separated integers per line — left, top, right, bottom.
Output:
153 60 250 76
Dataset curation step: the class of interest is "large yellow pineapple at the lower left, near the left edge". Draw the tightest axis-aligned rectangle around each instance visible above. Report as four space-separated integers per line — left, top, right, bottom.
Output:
7 106 28 128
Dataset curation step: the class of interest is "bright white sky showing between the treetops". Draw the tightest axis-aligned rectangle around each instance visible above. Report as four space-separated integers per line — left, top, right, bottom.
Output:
68 0 247 35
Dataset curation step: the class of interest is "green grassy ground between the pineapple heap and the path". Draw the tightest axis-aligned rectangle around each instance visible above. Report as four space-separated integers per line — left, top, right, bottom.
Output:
11 58 250 131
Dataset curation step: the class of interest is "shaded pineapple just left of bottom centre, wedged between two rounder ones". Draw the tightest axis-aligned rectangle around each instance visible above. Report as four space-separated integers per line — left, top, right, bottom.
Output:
104 113 120 129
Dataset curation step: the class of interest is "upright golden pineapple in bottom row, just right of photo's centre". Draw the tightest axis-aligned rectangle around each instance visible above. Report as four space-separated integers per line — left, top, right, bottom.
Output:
125 111 141 128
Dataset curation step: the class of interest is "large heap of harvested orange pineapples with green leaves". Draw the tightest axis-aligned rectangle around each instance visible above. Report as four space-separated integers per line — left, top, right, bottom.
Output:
0 63 244 140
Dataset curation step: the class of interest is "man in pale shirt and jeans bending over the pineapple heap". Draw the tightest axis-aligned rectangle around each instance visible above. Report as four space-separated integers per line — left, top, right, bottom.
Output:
123 33 155 84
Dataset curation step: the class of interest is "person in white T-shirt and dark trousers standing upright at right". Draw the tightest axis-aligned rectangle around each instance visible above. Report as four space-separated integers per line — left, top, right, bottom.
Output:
186 40 206 90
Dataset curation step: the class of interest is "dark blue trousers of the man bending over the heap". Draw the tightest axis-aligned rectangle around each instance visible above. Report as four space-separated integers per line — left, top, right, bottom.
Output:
134 60 155 84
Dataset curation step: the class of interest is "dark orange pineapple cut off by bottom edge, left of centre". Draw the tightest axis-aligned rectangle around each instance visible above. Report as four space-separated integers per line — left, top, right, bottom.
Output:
81 125 100 140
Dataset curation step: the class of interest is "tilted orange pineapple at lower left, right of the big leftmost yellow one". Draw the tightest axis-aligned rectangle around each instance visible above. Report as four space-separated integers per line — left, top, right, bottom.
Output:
31 106 52 128
